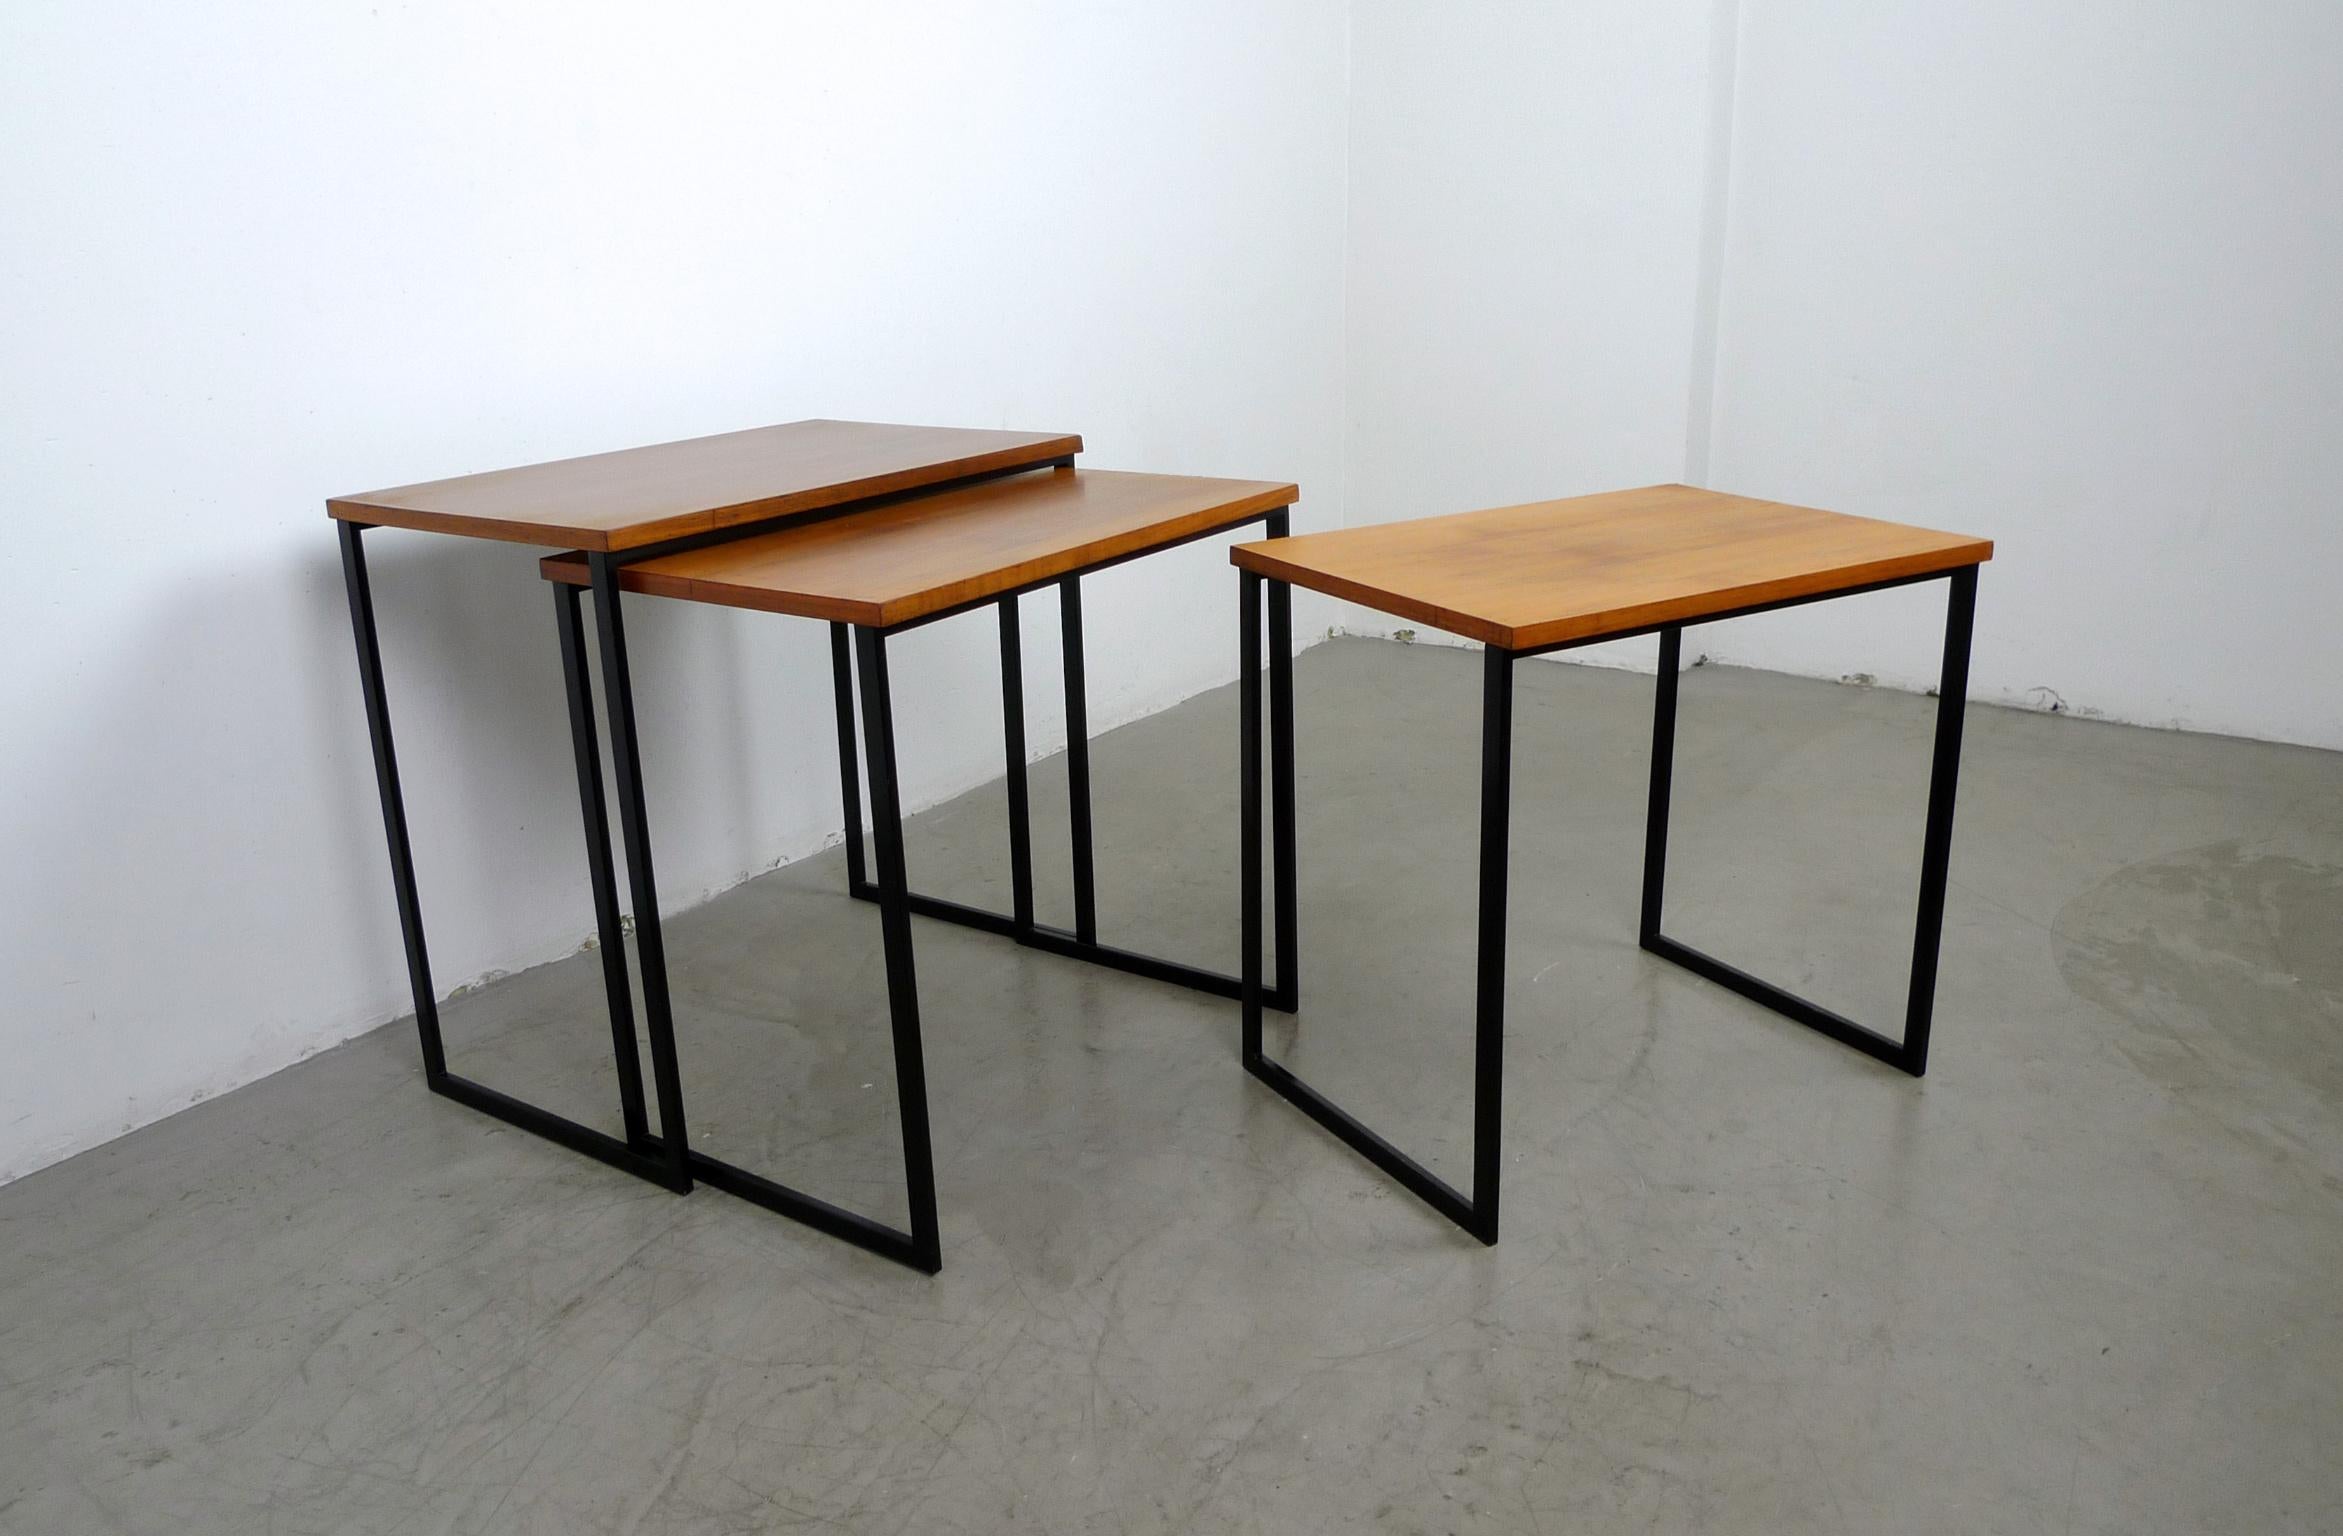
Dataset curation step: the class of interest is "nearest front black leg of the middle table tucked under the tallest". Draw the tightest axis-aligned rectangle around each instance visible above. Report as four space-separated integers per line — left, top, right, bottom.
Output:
855 630 944 1274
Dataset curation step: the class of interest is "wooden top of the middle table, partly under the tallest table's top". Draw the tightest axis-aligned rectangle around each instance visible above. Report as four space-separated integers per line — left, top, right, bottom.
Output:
539 468 1300 628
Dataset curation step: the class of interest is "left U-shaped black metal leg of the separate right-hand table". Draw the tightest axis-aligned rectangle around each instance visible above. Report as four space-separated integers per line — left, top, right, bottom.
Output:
1237 571 1514 1243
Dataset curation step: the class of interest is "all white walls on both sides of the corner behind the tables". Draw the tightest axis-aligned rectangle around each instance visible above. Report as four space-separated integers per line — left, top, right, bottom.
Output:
0 0 2343 1178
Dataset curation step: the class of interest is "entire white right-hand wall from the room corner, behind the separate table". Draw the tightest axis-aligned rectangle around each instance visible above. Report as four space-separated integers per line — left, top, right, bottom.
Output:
1347 0 2343 747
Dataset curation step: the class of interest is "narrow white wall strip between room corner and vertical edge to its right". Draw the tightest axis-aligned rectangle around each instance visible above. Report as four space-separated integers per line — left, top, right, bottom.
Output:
1345 0 1710 669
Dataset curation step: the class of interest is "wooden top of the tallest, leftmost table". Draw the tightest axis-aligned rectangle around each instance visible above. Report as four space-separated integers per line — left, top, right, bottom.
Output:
326 421 1082 550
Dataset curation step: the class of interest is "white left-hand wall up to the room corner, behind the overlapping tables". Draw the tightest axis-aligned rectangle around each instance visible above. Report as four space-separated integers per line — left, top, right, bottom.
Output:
0 0 1347 1178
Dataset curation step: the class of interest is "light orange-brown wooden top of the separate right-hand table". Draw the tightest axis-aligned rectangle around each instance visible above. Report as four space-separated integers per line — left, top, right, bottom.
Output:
1228 485 1994 651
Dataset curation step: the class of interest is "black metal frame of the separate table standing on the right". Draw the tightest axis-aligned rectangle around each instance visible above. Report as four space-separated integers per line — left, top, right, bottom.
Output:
1239 564 1977 1243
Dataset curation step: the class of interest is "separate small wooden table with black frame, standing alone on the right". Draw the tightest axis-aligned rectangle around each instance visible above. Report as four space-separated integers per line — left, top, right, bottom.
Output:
1230 485 1994 1243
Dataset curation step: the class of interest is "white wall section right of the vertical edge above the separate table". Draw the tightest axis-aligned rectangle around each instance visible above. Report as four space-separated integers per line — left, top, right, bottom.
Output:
1701 0 2343 747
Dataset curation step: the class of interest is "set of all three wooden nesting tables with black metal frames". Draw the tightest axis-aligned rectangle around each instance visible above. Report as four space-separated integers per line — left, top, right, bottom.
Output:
328 421 1992 1274
